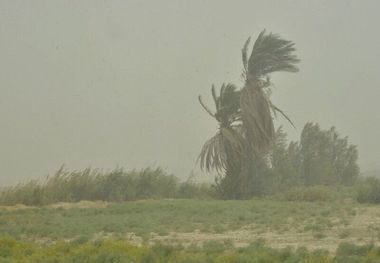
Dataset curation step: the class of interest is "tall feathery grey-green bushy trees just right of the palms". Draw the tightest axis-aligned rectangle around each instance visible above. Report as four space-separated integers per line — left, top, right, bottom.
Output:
262 123 359 196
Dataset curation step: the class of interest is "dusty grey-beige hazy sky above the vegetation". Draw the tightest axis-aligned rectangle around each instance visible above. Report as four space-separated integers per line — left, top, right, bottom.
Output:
0 0 380 186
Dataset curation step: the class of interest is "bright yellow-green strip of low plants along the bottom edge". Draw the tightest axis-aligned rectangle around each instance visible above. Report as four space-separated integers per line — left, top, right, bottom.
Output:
0 237 380 263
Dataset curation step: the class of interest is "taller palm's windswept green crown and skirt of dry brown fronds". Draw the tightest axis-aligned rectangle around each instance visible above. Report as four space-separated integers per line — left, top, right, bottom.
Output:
240 30 299 154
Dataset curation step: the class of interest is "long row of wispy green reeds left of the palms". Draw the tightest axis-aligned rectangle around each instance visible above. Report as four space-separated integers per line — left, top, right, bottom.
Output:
0 166 215 206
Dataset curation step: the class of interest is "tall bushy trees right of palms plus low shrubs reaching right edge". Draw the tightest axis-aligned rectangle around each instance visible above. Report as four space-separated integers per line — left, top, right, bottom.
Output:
268 123 380 203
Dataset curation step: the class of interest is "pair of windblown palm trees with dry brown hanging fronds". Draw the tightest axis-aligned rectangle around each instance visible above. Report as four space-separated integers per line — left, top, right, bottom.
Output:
198 30 299 198
